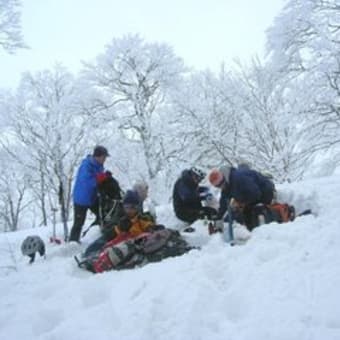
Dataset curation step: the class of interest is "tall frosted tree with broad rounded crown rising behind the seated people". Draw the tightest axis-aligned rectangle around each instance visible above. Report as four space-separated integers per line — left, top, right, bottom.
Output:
84 35 184 180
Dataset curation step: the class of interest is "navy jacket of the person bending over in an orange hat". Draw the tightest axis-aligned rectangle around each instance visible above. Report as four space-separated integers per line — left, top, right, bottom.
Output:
219 168 275 216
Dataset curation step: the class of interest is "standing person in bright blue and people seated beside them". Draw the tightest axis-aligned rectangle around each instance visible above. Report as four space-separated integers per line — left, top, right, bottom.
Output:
69 145 155 248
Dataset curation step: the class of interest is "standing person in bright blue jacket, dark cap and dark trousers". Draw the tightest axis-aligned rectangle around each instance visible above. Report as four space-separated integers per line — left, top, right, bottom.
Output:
69 145 109 243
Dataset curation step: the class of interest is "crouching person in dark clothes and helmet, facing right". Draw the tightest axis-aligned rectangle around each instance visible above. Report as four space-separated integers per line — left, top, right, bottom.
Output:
173 168 217 224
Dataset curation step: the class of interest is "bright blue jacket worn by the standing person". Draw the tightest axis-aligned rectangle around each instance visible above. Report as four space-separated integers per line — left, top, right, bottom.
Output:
73 155 104 207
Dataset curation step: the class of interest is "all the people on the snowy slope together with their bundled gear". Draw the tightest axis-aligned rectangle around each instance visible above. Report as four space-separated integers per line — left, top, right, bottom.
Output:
63 145 298 272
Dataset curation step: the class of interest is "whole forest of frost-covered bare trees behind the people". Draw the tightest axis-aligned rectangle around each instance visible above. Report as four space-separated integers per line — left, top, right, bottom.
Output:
0 0 340 231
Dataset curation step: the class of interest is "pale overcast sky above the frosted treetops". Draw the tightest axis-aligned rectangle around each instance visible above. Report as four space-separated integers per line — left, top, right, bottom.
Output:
0 0 284 88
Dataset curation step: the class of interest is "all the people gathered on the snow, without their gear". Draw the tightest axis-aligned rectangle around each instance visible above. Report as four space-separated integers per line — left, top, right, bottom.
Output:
69 145 275 249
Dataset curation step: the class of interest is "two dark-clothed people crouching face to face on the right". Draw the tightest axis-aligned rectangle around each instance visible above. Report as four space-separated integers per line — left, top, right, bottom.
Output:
173 164 275 230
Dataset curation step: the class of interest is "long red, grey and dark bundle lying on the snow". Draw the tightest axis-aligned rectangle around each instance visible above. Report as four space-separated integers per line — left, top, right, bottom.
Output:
78 228 193 273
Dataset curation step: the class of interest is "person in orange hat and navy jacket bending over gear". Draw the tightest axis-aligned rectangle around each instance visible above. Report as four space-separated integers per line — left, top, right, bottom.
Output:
209 166 275 225
